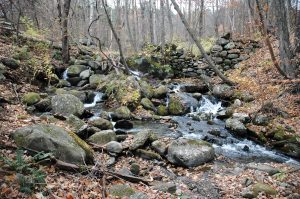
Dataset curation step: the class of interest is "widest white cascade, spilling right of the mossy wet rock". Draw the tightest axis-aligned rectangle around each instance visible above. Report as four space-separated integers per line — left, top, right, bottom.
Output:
197 96 223 116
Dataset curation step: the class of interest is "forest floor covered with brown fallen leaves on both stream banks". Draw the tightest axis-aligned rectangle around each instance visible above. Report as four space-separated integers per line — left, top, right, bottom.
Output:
0 35 300 199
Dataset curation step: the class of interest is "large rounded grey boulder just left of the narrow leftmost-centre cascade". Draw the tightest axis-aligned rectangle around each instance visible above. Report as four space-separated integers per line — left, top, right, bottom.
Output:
51 94 84 116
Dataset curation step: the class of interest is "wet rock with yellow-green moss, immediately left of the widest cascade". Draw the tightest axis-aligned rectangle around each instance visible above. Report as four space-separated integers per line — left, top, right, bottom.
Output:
169 93 198 115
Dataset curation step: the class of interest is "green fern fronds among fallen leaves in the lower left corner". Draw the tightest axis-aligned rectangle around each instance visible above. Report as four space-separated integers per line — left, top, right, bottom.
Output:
0 150 46 194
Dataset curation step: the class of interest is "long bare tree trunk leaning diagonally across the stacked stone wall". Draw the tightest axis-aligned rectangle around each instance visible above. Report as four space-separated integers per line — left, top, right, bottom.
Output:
171 0 235 85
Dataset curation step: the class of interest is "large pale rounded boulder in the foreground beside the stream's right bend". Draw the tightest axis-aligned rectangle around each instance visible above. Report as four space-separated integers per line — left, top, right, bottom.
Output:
167 138 215 167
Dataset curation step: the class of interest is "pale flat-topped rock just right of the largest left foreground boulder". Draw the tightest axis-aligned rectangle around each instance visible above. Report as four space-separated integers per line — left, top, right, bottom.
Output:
88 130 116 145
